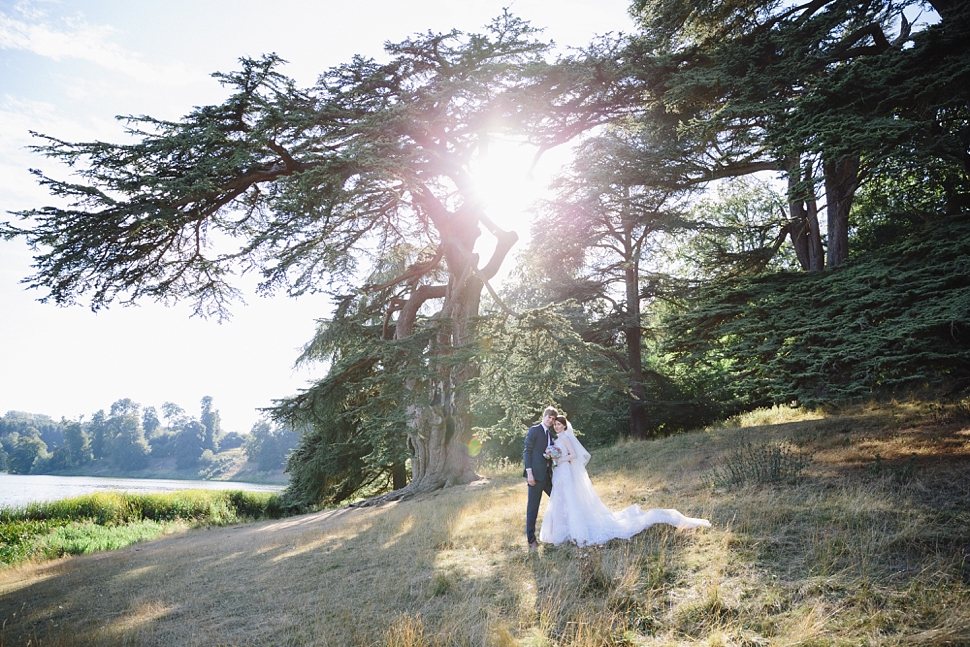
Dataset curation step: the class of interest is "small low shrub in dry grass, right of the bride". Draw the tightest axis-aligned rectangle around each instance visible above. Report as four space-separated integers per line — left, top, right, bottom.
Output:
705 442 812 488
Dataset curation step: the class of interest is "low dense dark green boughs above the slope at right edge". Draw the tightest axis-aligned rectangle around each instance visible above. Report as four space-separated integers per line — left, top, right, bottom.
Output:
664 216 970 406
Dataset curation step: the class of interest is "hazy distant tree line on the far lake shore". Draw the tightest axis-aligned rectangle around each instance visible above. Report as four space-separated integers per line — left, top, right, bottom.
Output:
0 396 298 474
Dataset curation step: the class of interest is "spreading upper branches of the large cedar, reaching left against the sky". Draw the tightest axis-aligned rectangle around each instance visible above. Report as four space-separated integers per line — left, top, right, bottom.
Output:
2 14 560 324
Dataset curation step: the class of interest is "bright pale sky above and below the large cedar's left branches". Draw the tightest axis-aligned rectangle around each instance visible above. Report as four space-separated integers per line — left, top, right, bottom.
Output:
0 0 632 432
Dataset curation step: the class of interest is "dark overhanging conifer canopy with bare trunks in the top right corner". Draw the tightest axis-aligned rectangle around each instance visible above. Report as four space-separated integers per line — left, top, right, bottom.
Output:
631 0 970 270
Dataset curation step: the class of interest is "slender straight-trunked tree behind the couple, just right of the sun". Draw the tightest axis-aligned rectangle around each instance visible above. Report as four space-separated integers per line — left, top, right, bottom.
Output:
530 127 692 438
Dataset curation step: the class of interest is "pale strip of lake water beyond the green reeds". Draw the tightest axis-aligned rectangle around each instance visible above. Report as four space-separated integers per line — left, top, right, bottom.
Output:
0 472 285 508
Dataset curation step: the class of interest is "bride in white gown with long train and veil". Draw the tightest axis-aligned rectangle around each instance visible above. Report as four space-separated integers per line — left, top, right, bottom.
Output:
539 416 711 546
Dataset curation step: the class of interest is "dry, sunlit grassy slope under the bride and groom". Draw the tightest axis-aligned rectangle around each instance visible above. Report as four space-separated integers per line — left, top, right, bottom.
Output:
0 403 970 647
